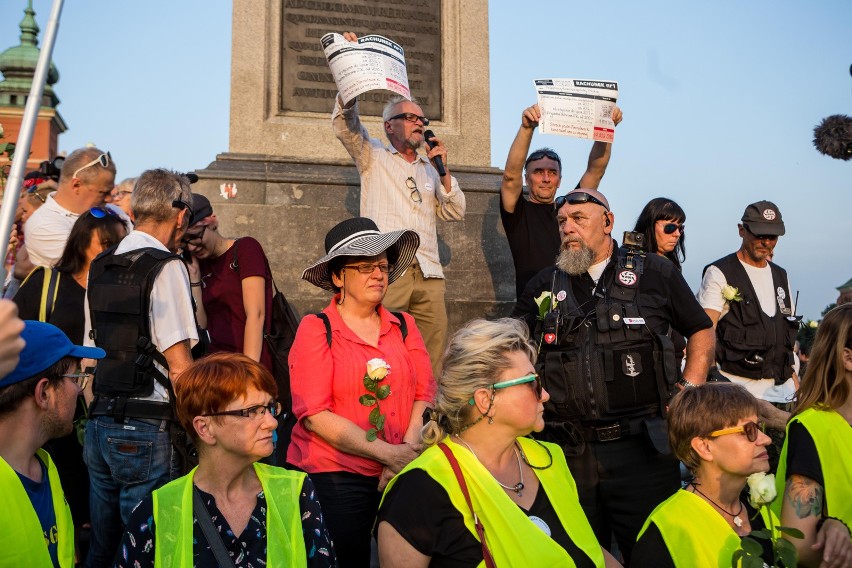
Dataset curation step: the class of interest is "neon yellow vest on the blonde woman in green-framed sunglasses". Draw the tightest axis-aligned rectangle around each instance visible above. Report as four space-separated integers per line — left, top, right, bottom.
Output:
385 438 604 568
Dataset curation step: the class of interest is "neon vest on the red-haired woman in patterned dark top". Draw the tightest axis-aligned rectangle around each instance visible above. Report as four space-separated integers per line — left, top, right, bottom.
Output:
153 463 308 568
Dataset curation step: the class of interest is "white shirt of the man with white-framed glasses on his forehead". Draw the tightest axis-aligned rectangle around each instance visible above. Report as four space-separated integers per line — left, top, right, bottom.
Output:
24 192 80 267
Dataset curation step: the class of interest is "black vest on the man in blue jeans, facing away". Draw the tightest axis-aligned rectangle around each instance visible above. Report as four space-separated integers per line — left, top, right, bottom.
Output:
87 247 180 397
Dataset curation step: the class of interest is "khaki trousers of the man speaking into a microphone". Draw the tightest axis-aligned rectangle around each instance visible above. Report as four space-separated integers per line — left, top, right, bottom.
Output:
382 261 447 377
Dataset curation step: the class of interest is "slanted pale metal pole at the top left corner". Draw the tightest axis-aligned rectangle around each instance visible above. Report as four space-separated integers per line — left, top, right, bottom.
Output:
0 0 63 286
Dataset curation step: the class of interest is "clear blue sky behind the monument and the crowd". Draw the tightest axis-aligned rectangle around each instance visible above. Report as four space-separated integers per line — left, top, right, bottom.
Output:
0 0 852 318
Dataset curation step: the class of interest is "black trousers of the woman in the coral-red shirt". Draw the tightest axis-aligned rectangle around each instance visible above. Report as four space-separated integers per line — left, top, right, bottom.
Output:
310 471 382 568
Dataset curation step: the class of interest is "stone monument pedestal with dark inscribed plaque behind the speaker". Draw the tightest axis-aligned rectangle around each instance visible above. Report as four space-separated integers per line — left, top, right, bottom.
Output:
193 0 515 331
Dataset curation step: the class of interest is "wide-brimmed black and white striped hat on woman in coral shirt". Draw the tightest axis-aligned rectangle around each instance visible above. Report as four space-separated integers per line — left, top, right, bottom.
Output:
302 217 420 290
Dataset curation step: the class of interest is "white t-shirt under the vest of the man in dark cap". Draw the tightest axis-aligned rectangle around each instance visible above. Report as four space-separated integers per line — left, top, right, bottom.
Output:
697 260 796 402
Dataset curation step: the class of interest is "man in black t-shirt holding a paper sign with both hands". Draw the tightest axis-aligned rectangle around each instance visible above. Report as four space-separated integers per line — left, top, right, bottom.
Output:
500 104 622 298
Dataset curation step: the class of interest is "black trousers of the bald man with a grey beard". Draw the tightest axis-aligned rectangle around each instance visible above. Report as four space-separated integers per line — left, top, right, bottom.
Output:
566 435 680 566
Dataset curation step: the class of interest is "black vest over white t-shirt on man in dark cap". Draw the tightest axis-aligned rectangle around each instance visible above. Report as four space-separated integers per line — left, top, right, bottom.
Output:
705 253 801 385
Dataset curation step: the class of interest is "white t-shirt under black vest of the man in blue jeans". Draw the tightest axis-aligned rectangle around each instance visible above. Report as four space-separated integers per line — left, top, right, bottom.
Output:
83 231 198 402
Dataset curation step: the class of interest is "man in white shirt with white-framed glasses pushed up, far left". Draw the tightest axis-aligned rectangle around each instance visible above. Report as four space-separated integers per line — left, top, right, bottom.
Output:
15 147 115 278
